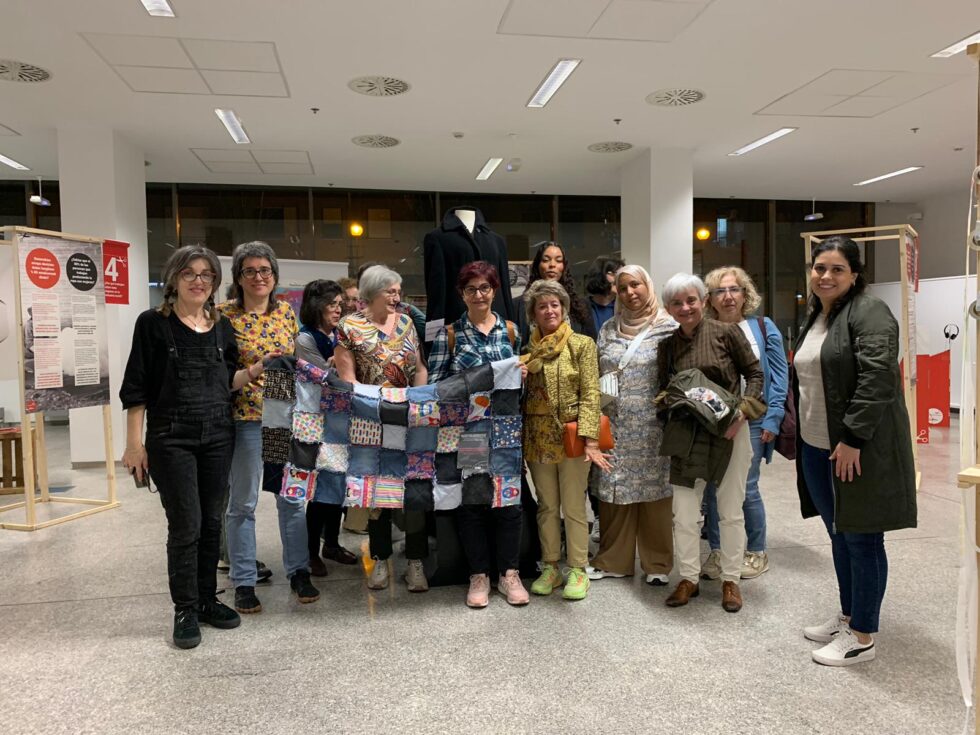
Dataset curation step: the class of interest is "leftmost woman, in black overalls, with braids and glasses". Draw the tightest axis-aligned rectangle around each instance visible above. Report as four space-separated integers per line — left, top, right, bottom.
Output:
119 245 263 648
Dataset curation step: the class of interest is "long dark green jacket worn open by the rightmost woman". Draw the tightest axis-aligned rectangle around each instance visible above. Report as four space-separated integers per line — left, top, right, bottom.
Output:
793 293 916 533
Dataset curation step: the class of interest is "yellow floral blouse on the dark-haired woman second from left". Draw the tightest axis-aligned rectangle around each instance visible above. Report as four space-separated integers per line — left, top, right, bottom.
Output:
218 301 299 421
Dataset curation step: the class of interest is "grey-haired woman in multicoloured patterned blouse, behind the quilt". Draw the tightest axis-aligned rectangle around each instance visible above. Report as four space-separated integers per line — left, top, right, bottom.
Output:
334 265 429 592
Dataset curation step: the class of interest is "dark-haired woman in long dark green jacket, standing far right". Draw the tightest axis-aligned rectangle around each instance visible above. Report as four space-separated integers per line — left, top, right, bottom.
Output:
793 236 916 666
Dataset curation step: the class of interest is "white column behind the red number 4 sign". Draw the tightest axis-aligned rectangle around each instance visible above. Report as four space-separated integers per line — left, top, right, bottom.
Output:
58 126 149 466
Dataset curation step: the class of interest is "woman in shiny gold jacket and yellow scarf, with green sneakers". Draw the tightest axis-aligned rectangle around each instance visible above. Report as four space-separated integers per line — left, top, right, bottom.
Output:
521 280 610 600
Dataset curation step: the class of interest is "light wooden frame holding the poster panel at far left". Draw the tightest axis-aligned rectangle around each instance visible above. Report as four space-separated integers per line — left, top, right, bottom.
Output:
0 227 119 531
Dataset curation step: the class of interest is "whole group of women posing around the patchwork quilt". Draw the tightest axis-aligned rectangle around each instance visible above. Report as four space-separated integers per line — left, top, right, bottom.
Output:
121 238 916 666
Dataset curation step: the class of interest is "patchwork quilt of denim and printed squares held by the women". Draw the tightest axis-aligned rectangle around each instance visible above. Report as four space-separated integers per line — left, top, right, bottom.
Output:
262 357 523 511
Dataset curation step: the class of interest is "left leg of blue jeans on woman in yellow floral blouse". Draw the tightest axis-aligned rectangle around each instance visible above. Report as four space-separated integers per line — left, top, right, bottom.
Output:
225 421 262 587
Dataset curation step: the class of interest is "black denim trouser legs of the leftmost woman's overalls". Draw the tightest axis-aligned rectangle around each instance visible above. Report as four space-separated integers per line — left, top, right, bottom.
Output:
146 410 235 609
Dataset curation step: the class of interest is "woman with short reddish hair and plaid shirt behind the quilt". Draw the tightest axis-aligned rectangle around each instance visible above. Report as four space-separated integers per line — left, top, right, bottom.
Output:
429 260 529 608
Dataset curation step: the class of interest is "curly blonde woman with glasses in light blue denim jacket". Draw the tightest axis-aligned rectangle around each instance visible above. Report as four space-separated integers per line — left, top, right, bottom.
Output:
701 266 789 579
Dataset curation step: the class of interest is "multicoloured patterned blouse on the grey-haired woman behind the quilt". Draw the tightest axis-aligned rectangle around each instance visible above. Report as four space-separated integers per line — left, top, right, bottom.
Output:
337 311 419 388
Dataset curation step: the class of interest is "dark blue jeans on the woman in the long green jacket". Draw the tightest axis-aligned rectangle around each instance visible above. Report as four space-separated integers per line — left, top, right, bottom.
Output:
803 442 888 633
